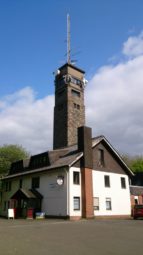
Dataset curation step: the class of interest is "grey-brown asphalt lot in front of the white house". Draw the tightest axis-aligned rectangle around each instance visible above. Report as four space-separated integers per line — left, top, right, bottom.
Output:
0 219 143 255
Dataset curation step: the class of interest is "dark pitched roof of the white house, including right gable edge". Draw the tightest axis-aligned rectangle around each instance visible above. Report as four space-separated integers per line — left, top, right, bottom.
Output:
3 136 134 179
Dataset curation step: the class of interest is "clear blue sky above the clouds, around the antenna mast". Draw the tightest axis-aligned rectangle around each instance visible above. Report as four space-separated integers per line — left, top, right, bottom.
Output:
0 0 143 97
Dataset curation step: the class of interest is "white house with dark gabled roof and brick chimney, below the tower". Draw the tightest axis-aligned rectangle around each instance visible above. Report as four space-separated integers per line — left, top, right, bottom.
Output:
0 127 133 219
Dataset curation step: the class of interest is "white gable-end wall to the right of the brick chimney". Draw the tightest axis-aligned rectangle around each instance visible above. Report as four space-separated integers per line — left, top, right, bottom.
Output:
93 170 131 216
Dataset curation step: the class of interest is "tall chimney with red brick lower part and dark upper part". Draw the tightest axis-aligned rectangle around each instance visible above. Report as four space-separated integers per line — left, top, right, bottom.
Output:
78 126 94 219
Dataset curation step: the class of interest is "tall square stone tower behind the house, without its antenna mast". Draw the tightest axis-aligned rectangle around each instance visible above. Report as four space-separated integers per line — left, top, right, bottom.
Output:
53 63 85 149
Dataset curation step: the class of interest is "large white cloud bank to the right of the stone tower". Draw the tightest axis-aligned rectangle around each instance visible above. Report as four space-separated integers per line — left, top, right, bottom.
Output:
86 38 143 154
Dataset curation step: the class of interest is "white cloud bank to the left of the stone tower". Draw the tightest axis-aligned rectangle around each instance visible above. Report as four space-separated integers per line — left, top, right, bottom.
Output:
0 87 54 153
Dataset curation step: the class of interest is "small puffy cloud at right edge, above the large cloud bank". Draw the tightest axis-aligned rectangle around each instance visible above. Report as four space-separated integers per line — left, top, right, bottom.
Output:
123 32 143 57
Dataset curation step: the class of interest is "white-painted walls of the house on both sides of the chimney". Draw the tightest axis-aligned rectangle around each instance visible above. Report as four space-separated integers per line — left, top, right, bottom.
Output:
0 167 131 216
